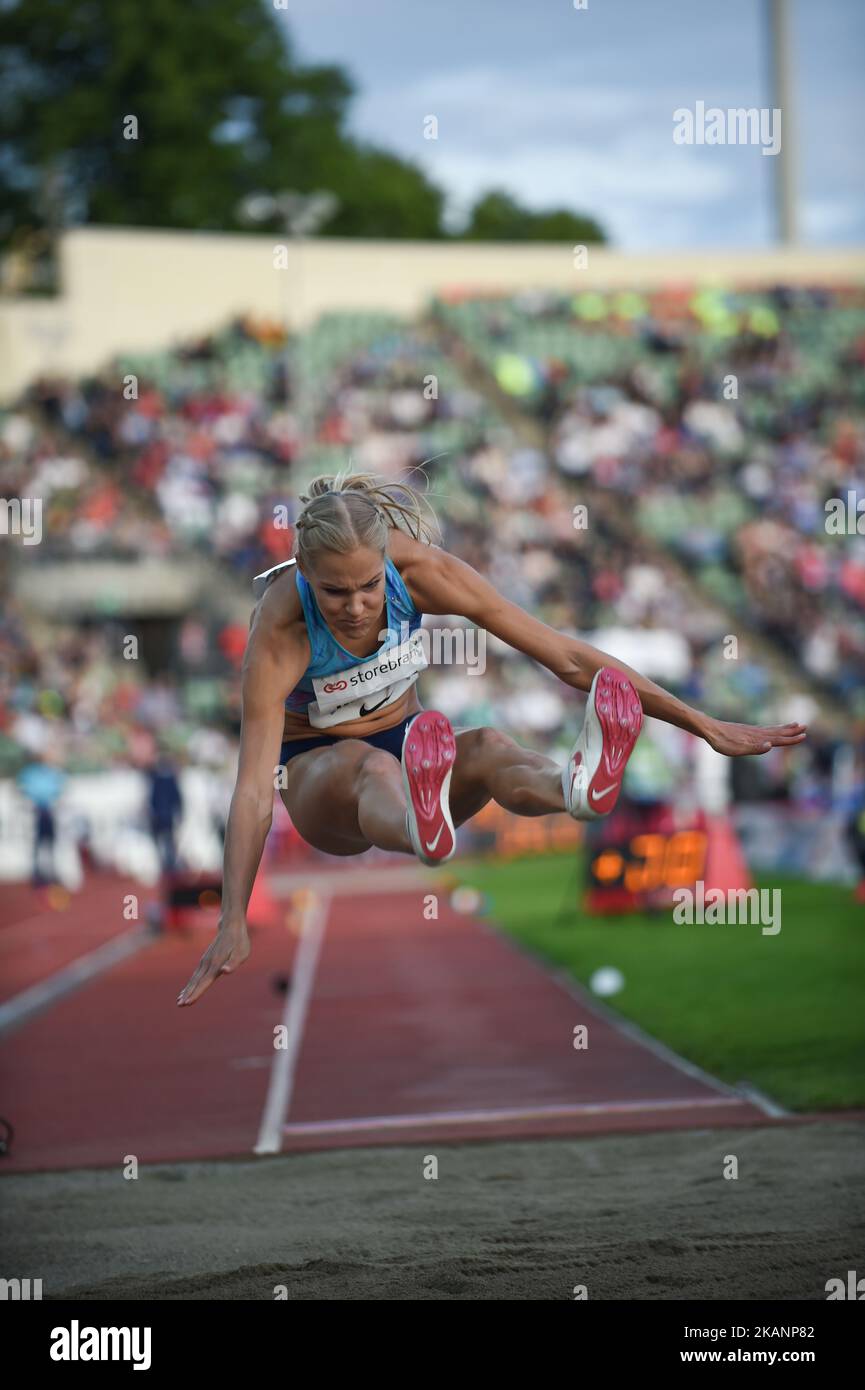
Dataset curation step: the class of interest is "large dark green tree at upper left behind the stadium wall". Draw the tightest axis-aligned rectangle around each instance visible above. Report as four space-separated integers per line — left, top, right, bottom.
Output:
0 0 442 245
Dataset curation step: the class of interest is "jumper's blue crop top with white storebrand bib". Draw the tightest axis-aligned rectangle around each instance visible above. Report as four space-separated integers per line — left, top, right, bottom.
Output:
252 556 430 728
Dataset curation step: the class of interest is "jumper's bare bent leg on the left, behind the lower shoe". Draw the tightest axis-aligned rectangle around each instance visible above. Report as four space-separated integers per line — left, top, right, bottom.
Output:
281 738 413 855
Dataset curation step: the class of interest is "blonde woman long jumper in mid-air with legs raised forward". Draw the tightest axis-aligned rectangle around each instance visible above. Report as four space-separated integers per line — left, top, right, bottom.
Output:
178 474 805 1005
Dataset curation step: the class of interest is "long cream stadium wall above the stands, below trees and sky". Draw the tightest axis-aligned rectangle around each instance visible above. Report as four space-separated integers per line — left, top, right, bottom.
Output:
0 227 865 402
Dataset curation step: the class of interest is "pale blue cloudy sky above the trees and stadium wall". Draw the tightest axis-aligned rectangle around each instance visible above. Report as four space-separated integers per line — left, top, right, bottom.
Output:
281 0 865 249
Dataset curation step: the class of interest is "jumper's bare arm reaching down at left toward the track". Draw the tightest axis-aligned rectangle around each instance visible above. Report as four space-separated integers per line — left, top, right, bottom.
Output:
177 584 310 1005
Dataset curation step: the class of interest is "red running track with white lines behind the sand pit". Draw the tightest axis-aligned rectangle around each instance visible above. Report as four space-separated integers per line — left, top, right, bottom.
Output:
0 866 768 1173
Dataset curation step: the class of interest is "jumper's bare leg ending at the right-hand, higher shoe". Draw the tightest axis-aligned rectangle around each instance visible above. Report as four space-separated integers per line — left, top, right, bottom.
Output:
451 728 565 826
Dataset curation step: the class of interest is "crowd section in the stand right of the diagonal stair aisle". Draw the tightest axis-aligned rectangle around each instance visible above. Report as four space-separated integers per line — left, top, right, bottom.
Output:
438 288 865 713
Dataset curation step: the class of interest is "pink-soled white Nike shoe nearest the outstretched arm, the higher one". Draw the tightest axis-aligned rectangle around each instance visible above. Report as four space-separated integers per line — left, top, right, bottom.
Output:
562 666 642 820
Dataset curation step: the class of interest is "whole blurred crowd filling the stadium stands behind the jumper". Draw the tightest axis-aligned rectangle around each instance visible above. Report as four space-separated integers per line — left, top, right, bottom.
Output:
0 291 865 878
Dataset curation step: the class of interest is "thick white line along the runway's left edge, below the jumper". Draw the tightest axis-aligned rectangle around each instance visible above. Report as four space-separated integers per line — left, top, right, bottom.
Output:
253 894 331 1154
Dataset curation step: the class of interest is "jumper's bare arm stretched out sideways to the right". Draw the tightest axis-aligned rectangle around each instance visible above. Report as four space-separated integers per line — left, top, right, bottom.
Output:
406 546 807 758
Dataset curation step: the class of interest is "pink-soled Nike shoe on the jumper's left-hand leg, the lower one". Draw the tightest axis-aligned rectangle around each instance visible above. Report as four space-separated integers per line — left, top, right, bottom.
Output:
402 709 456 865
